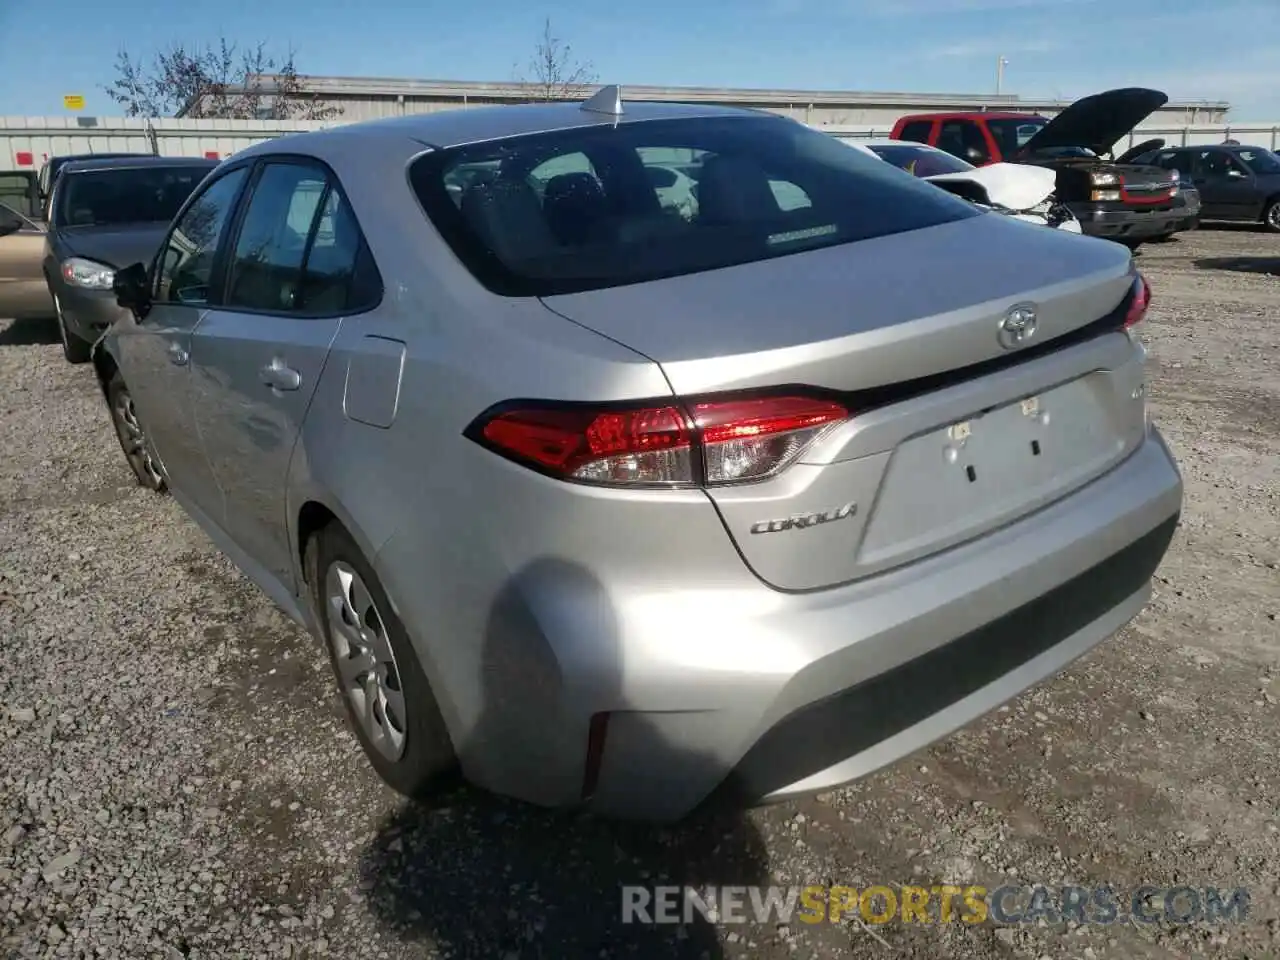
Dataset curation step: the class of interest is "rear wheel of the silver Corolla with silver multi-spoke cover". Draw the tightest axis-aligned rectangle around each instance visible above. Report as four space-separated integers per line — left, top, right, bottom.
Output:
306 522 457 799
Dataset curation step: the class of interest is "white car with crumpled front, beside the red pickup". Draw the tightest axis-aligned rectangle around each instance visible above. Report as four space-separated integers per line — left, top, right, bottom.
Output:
841 138 1080 233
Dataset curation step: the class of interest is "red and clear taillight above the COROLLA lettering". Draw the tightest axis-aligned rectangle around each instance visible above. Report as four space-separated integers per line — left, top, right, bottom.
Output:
468 397 849 486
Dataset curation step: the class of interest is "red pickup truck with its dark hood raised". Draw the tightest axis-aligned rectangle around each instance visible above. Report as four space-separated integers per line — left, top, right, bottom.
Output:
892 87 1194 247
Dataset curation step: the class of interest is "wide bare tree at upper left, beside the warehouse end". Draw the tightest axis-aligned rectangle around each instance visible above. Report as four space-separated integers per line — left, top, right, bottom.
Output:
102 38 342 120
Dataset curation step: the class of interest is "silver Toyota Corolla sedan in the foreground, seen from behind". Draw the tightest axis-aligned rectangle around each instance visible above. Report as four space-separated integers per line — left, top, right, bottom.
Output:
95 88 1181 819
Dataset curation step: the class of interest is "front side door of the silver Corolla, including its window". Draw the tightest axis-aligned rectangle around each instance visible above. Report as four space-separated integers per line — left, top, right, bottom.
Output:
108 166 250 517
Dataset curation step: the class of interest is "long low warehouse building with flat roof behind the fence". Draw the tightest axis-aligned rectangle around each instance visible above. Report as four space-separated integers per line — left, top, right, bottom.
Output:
183 77 1229 127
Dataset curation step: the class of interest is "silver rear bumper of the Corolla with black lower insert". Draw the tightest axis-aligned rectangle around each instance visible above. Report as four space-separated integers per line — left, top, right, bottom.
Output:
427 428 1183 820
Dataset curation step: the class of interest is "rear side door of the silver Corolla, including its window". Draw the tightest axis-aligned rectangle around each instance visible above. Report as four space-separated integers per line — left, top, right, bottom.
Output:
192 159 362 589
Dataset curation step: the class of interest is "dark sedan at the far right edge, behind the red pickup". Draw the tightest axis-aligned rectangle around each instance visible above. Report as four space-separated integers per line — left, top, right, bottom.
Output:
1138 141 1280 233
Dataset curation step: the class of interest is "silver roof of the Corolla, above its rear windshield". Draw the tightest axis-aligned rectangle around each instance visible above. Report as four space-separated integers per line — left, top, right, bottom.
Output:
236 101 778 159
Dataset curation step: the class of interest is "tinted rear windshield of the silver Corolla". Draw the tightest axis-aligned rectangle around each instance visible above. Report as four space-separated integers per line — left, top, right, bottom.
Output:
410 116 982 296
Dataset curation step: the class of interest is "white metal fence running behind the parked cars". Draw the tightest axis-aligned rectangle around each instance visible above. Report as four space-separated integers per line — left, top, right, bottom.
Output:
0 116 1280 172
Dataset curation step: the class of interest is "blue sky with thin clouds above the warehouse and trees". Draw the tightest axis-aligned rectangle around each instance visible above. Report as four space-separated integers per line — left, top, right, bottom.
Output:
0 0 1280 123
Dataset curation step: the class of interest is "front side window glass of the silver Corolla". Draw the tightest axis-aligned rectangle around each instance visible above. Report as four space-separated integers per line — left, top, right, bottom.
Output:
155 166 248 306
